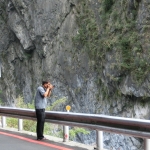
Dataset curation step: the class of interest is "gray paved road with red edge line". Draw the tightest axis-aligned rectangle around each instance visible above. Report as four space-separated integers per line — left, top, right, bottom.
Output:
0 130 87 150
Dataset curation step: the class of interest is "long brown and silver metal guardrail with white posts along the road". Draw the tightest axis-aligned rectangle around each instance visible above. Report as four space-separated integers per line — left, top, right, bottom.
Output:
0 107 150 150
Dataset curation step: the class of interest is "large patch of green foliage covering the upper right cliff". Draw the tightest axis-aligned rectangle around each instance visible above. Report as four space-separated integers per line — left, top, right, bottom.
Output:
73 0 150 98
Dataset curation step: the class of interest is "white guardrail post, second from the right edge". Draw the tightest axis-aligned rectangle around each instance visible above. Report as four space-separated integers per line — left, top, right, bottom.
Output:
96 130 103 150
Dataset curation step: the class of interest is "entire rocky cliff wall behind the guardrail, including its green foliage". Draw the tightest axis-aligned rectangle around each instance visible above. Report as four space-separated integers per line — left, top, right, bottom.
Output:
0 0 150 150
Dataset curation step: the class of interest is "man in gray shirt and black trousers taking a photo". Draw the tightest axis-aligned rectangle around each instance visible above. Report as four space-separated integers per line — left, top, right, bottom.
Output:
35 81 53 140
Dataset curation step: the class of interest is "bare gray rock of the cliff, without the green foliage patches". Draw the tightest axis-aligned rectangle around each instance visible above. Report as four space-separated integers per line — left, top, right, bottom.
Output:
0 0 150 150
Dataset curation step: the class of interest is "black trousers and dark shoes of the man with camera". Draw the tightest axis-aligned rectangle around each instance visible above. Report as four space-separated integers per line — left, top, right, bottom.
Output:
36 109 45 139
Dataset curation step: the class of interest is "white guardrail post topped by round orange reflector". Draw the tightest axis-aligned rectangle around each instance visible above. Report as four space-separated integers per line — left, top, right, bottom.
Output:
63 105 71 142
